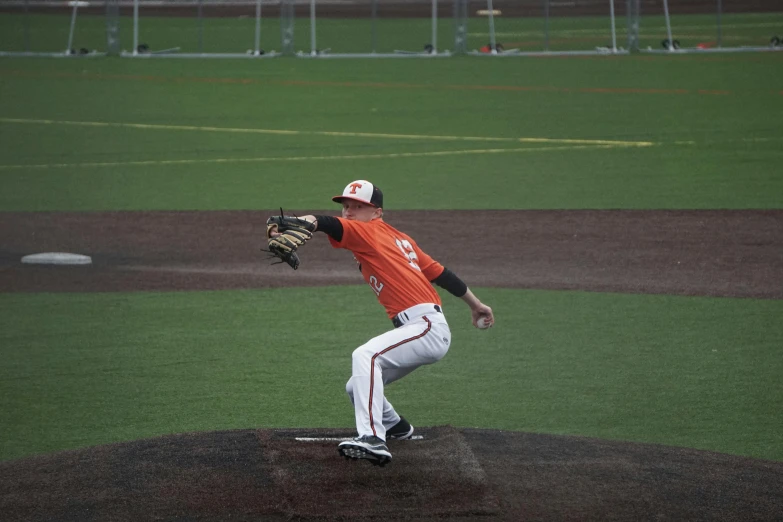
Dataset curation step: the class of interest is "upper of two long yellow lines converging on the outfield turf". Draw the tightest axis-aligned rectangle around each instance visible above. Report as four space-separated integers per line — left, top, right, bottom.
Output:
0 118 653 147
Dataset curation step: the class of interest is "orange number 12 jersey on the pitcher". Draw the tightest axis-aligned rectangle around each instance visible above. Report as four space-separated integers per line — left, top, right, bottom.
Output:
329 218 443 318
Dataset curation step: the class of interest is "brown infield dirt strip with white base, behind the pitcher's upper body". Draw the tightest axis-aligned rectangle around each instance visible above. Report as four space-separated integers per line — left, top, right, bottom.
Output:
0 210 783 299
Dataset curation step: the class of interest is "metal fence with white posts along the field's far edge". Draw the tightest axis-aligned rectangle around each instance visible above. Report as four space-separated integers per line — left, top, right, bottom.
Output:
0 0 783 58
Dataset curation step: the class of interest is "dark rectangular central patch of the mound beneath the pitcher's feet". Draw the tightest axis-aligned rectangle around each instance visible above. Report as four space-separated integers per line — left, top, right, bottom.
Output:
259 428 500 520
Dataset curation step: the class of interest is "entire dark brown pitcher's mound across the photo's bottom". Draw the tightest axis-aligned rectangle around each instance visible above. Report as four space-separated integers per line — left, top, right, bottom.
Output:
0 427 783 521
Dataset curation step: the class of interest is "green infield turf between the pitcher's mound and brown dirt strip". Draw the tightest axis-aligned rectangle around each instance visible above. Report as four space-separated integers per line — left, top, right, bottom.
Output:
0 286 783 460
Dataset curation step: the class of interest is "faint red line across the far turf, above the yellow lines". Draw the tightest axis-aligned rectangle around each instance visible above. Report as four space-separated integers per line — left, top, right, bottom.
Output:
0 71 736 96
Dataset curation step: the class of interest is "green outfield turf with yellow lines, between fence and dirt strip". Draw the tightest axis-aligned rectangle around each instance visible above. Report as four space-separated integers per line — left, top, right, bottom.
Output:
0 53 783 210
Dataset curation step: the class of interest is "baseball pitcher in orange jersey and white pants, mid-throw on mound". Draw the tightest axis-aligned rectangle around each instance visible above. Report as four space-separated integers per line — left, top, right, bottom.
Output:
267 180 494 466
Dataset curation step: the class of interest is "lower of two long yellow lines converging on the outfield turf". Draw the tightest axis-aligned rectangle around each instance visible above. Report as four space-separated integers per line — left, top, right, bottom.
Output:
0 145 628 170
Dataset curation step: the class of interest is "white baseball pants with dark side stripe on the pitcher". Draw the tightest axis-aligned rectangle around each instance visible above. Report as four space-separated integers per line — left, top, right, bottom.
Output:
345 303 451 440
